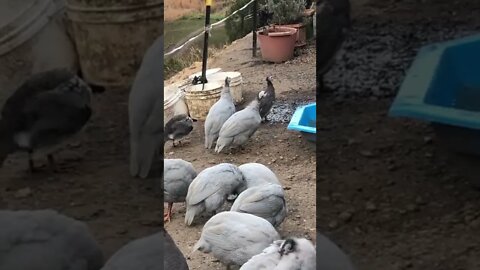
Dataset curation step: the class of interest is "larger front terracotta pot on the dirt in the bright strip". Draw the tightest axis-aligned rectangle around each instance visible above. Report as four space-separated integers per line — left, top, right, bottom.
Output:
257 26 297 63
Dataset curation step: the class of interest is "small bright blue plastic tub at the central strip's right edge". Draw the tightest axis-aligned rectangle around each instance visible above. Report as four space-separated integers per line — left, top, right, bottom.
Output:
287 103 317 142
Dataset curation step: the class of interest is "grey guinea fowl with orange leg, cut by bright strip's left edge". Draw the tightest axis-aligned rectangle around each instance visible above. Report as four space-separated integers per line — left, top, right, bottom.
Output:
163 159 197 221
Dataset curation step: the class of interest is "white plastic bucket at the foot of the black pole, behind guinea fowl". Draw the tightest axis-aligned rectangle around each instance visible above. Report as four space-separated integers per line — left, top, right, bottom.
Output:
185 82 223 121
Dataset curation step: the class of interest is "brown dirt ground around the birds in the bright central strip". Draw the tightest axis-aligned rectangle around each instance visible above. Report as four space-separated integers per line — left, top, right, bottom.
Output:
165 36 316 269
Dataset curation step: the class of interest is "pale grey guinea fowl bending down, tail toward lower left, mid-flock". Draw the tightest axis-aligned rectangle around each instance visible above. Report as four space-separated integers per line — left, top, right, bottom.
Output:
185 163 246 226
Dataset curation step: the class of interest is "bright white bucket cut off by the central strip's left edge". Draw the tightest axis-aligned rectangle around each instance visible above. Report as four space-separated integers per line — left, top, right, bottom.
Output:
163 84 188 124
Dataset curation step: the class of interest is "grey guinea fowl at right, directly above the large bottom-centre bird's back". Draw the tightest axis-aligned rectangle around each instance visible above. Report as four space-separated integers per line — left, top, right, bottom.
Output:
230 183 287 227
